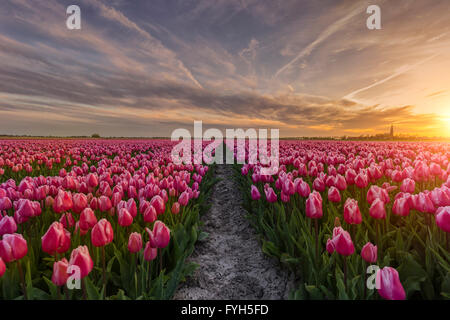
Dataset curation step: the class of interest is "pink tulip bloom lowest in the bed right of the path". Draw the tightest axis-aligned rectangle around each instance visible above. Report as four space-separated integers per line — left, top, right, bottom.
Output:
376 267 406 300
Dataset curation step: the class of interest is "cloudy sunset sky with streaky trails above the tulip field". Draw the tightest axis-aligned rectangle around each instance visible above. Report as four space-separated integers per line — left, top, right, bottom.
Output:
0 0 450 137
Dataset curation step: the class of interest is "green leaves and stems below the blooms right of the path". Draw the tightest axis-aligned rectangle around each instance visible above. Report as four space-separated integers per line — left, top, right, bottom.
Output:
235 165 450 300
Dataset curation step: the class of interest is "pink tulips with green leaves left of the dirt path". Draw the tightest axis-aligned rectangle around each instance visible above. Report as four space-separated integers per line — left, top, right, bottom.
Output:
0 140 214 299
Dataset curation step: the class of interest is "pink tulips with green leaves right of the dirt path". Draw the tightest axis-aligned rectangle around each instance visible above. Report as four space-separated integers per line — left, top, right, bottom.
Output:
235 141 450 300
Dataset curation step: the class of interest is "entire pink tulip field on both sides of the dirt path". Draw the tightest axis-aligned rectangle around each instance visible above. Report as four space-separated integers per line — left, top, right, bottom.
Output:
0 139 450 300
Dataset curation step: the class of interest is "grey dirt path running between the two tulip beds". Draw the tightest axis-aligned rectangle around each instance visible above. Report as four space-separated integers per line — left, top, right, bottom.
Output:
174 165 293 300
